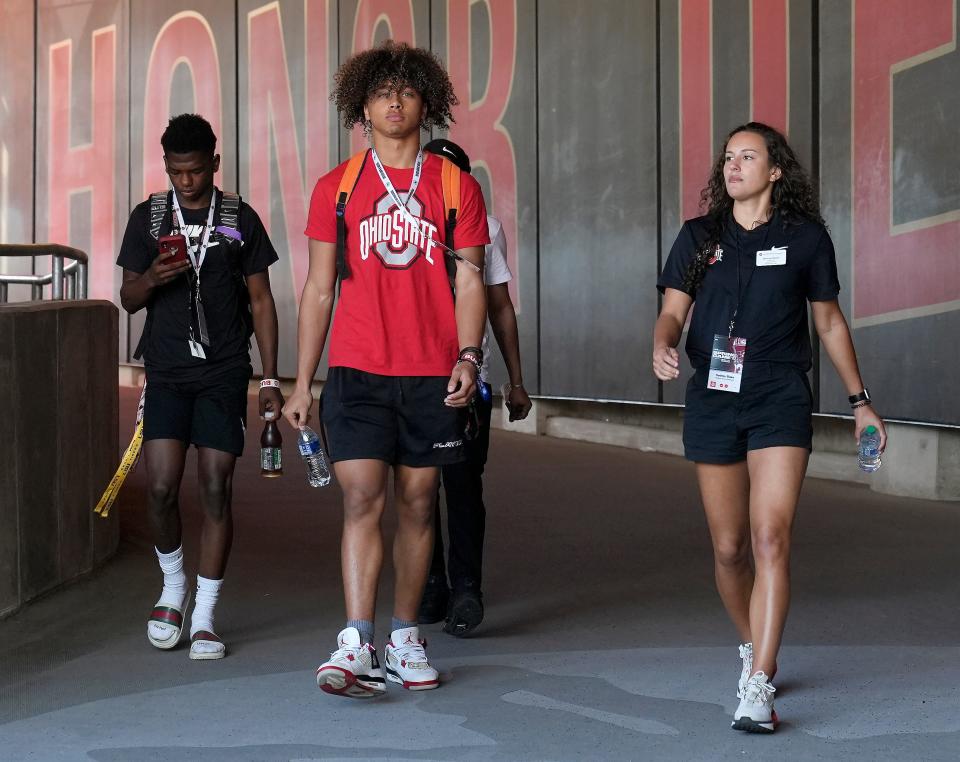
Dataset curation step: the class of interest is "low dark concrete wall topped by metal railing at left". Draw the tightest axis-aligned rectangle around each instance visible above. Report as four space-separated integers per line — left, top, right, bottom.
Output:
0 301 119 616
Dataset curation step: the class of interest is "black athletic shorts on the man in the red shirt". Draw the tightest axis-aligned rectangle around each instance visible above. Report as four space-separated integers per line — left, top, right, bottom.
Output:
320 367 465 467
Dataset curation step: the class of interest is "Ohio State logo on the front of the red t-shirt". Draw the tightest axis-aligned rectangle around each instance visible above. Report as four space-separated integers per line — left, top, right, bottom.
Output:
360 194 438 270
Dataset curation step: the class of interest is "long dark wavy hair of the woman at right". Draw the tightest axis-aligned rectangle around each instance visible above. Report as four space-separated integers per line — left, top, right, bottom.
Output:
683 122 823 294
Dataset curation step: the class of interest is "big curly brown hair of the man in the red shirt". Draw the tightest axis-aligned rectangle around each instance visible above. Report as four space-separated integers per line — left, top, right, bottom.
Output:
330 40 459 130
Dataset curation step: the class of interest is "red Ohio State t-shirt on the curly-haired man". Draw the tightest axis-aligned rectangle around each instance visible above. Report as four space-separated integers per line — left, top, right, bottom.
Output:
305 153 490 376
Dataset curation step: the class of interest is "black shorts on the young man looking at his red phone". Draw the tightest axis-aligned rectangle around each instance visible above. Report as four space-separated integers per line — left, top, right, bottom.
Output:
143 366 251 457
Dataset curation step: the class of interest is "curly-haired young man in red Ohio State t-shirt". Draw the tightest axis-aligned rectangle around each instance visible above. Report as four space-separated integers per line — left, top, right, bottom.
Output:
284 41 489 698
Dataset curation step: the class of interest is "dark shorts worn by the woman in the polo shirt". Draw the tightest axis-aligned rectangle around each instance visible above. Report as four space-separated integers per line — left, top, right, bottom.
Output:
683 362 813 464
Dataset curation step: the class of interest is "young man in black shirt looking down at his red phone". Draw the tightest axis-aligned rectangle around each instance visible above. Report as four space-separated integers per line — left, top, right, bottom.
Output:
117 114 283 659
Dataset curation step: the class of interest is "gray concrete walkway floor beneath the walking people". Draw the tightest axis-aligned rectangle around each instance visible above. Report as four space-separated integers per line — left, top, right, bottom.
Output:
0 391 960 762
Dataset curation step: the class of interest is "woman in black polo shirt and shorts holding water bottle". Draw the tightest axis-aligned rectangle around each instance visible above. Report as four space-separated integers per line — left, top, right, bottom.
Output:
653 122 886 732
